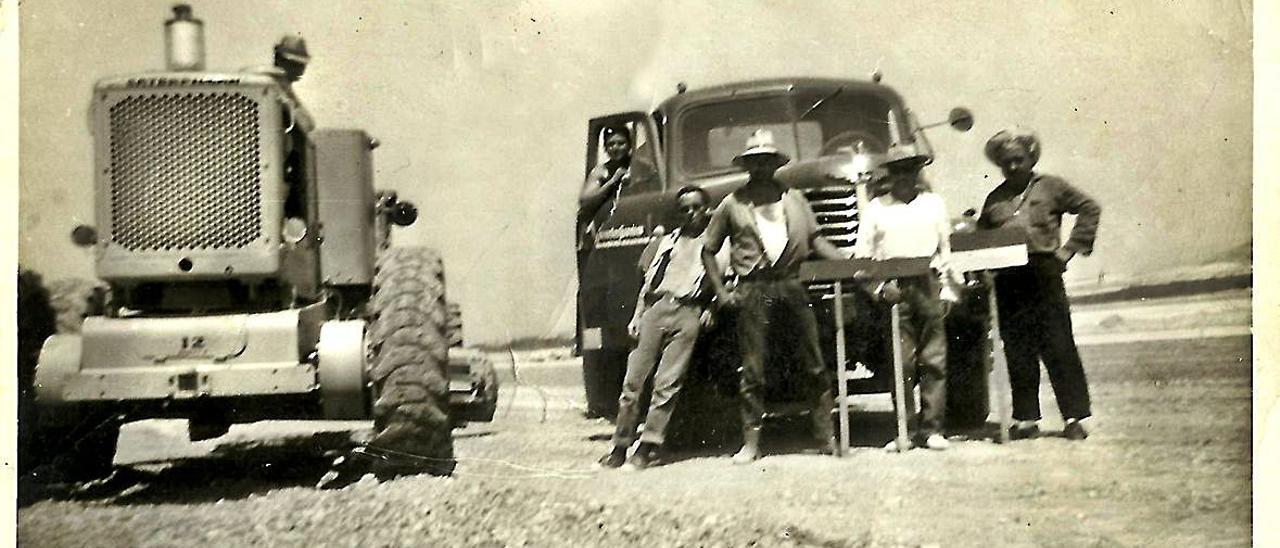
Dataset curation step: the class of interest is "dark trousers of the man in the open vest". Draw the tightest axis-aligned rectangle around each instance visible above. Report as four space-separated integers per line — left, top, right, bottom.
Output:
735 278 835 442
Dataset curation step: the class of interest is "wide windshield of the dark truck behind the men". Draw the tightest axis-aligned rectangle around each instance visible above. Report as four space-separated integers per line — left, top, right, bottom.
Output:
680 90 901 177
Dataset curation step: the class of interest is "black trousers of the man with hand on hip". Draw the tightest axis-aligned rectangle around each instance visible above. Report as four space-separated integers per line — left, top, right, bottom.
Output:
996 254 1089 420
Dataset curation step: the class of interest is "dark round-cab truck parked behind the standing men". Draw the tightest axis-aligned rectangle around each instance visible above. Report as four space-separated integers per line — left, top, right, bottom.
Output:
576 73 991 444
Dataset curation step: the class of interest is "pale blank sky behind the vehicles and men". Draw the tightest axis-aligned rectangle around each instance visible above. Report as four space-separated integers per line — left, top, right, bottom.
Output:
18 0 1253 343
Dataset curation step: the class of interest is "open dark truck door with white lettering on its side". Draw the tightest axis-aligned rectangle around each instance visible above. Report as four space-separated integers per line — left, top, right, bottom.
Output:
576 113 673 416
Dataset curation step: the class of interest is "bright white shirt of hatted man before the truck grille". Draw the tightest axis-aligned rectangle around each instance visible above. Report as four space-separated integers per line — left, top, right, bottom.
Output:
854 192 951 260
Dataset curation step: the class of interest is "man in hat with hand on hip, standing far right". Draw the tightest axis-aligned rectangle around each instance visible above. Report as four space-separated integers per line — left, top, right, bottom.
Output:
978 128 1102 440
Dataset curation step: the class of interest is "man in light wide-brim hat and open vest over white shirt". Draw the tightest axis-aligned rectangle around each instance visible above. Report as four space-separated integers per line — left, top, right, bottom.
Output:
703 129 846 463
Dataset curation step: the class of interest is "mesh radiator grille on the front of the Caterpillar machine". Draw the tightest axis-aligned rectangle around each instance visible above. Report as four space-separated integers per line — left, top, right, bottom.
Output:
109 91 261 251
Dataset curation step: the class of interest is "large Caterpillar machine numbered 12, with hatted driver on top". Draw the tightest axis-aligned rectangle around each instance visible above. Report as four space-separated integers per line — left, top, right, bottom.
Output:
35 5 498 479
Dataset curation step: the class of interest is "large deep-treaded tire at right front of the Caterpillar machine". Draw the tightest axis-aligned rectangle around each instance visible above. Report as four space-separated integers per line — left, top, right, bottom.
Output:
369 247 454 476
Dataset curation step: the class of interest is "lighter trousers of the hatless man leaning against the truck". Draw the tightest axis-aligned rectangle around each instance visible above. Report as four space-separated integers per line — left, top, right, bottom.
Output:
613 297 703 447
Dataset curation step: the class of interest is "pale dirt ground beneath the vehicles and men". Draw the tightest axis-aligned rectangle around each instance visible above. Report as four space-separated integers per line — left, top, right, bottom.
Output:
18 337 1252 547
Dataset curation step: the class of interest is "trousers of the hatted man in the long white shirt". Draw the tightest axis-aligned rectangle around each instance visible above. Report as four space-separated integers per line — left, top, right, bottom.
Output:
897 275 947 437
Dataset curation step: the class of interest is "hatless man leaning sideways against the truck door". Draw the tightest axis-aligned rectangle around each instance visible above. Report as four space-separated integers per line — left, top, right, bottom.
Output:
599 186 719 470
